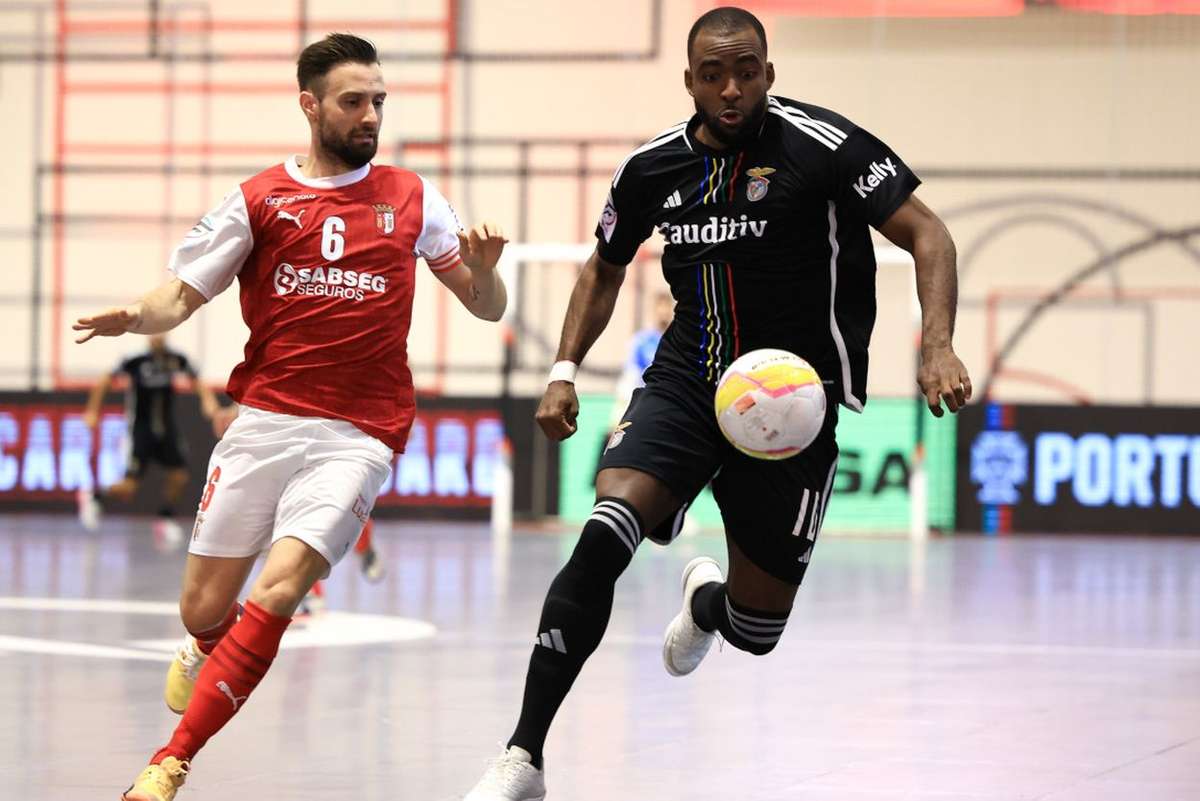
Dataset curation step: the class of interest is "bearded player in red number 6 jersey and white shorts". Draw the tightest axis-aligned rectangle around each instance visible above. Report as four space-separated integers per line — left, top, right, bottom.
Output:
74 34 506 801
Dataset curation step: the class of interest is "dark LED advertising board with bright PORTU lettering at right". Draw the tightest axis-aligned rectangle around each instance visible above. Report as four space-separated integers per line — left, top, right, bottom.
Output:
956 404 1200 534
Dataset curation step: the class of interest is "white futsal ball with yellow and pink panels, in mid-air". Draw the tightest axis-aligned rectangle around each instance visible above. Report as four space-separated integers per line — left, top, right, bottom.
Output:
714 348 826 459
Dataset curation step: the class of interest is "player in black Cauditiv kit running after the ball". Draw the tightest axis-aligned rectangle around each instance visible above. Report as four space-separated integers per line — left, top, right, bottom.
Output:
467 8 971 801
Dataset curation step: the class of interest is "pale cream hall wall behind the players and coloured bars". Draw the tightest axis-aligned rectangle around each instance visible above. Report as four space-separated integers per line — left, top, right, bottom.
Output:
0 0 1200 403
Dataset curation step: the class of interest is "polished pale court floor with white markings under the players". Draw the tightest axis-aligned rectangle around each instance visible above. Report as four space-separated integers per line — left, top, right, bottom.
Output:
0 516 1200 801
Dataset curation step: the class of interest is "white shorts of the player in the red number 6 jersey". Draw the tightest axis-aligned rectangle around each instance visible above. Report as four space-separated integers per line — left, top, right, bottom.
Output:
187 405 392 567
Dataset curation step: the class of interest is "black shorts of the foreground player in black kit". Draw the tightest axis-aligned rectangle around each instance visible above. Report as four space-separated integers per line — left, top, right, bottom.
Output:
598 371 838 584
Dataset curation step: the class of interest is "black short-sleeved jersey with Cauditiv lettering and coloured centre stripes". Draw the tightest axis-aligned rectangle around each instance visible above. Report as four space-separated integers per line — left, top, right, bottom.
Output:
596 97 920 410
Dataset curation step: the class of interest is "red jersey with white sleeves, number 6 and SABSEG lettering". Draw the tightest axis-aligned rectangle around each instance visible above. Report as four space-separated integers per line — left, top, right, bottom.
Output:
170 157 461 451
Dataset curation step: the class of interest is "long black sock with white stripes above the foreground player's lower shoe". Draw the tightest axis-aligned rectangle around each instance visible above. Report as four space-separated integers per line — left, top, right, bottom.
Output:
509 498 642 770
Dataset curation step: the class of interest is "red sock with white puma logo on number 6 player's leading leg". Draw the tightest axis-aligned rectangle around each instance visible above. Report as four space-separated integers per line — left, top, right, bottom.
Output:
150 601 292 765
